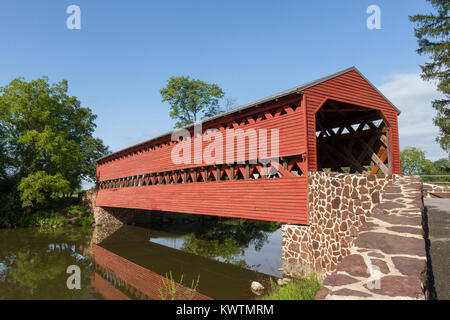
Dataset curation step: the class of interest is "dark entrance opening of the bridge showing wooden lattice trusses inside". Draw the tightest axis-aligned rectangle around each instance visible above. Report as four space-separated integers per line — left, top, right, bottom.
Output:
316 100 391 174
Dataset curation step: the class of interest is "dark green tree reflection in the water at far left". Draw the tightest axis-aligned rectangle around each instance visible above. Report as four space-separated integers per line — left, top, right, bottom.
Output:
0 228 94 300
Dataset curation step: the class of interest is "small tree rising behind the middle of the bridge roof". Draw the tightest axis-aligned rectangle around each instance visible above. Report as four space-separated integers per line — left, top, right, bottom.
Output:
160 76 224 128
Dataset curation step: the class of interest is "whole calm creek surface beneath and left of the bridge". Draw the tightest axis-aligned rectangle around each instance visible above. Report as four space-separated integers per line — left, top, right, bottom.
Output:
0 219 281 300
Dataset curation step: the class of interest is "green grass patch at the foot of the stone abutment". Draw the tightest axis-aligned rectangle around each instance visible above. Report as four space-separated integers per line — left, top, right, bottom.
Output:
259 274 322 300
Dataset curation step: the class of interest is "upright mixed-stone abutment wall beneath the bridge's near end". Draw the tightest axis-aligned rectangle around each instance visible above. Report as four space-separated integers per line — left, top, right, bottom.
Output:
282 172 395 276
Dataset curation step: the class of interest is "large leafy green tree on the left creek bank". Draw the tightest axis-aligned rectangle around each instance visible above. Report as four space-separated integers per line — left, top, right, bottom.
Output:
0 77 109 207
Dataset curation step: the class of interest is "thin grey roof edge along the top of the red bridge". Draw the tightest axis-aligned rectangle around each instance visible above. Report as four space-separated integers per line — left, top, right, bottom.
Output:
95 66 400 162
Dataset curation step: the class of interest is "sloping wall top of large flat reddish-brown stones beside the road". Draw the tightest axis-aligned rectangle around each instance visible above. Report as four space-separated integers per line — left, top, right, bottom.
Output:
316 176 428 300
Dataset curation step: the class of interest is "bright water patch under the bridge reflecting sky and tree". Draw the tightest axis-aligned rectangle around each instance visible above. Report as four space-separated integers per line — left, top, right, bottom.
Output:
150 220 281 277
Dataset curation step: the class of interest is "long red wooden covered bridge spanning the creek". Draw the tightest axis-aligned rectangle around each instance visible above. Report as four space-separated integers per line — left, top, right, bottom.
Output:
96 67 400 224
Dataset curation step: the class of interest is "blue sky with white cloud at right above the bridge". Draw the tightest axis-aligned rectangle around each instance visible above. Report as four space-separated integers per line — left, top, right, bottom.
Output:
0 0 446 159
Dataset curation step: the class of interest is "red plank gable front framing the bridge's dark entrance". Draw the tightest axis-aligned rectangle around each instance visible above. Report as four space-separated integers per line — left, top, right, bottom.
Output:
303 70 401 174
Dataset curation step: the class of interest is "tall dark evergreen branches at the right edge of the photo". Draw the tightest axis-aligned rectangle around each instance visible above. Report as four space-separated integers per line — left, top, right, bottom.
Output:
409 0 450 152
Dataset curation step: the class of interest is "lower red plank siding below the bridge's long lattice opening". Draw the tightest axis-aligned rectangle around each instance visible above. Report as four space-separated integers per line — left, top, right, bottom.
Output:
96 177 308 224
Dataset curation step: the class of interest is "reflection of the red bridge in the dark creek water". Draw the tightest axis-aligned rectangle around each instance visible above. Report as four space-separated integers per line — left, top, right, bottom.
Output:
91 222 280 300
